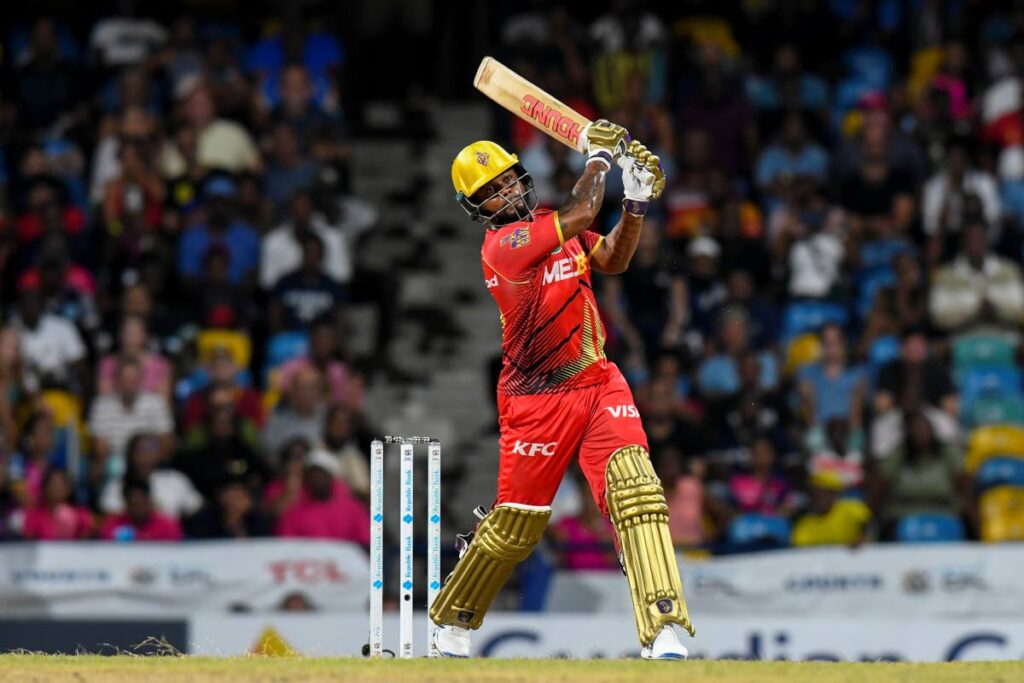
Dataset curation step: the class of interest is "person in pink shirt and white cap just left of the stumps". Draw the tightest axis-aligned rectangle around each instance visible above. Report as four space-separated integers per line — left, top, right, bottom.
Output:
278 451 370 546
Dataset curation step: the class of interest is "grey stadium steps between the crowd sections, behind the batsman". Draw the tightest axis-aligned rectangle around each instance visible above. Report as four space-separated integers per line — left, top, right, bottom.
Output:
353 103 512 547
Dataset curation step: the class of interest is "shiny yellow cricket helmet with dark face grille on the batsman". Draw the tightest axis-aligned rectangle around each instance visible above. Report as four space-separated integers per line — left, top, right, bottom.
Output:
452 140 537 225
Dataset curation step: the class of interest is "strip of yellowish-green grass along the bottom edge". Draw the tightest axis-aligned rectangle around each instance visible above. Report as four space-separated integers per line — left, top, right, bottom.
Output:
0 654 1024 683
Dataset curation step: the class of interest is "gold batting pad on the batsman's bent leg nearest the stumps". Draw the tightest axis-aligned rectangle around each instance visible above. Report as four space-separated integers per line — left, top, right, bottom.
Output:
430 505 551 629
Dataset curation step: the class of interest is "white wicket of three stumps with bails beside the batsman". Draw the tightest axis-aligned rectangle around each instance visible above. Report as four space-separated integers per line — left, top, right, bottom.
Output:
370 436 441 658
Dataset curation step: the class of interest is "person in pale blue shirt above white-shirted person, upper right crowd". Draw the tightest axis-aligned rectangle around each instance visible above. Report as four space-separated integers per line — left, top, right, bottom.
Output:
757 112 828 212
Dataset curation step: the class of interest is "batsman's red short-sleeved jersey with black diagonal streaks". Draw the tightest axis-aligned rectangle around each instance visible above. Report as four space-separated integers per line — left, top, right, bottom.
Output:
480 210 609 395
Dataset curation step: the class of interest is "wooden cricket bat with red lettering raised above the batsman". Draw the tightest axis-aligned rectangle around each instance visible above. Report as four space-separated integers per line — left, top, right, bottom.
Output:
473 57 591 152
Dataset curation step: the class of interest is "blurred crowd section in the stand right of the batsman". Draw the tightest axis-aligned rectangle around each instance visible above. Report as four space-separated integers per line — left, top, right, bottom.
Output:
501 0 1024 569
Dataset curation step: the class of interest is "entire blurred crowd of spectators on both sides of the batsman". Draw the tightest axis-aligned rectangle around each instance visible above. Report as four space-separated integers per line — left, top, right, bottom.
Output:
6 0 1024 568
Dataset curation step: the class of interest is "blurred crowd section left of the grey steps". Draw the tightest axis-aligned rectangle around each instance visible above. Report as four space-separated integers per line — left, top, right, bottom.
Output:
0 15 387 544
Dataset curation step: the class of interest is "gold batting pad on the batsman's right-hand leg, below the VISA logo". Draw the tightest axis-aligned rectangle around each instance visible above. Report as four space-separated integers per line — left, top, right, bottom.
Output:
604 445 693 645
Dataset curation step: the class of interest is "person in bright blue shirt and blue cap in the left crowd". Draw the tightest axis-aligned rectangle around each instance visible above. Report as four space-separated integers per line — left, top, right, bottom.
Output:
178 176 260 286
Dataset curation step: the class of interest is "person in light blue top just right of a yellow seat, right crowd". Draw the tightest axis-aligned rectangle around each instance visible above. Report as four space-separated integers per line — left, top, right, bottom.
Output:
799 325 866 430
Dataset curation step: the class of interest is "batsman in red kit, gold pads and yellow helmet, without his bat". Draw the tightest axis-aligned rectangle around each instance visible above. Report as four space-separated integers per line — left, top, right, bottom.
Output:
430 120 693 659
